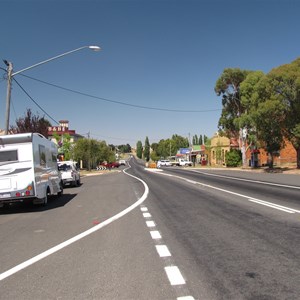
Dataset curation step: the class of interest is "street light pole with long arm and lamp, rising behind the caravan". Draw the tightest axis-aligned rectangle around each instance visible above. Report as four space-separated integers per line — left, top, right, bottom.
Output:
4 46 101 134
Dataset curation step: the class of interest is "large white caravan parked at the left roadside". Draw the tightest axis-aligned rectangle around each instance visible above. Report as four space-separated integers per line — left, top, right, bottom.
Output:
0 133 63 207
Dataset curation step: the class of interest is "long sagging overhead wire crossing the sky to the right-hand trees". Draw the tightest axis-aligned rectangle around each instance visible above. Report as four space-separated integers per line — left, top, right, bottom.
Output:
20 74 221 113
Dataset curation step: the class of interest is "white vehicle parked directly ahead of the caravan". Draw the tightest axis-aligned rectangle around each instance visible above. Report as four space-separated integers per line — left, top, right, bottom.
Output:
57 160 80 186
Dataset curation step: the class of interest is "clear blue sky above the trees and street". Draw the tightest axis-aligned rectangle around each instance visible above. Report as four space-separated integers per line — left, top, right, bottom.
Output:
0 0 300 146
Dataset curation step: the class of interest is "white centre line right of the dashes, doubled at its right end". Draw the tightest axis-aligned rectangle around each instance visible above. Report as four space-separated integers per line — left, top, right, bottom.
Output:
159 173 300 213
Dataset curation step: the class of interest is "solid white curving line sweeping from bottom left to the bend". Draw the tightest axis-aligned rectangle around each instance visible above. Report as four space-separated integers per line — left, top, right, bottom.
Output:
0 162 149 281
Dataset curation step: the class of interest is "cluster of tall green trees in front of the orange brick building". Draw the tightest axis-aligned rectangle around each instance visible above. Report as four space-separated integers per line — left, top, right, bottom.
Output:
215 58 300 168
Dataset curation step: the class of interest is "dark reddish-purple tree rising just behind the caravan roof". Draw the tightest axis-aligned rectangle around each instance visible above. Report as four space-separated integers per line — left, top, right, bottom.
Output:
11 108 52 138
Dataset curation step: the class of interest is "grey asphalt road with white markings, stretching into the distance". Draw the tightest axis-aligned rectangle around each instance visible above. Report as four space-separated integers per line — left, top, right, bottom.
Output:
0 159 300 300
